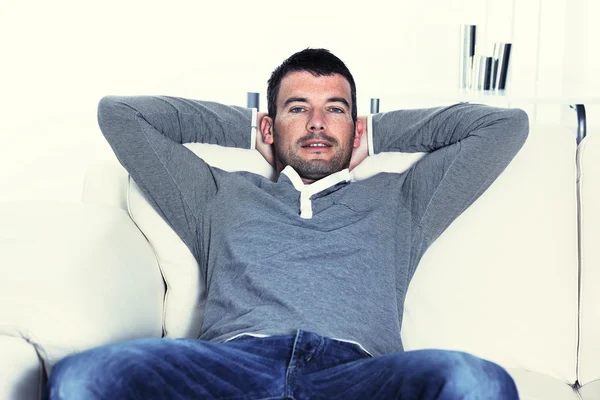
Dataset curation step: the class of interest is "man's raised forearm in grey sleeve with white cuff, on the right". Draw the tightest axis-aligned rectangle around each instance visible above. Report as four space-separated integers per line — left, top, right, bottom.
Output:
368 103 527 154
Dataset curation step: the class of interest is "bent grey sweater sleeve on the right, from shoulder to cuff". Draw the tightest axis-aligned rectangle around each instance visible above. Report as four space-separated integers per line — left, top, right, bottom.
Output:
373 103 529 268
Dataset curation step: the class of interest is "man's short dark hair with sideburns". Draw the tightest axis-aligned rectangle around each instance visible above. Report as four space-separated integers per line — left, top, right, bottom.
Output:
267 48 358 123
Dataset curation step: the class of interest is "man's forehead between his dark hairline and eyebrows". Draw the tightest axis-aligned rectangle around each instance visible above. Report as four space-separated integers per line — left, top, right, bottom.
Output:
277 71 352 105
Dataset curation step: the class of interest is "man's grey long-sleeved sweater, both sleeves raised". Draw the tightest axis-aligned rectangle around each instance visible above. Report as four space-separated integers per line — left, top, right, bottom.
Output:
98 97 528 355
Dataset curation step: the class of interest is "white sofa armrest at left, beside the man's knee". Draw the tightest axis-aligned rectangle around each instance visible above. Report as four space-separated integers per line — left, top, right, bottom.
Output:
0 202 164 378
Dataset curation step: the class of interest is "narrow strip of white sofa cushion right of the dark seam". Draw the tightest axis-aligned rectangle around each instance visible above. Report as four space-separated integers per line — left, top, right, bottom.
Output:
577 134 600 391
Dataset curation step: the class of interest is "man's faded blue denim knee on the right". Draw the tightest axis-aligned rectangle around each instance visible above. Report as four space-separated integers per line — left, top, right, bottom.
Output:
432 351 519 400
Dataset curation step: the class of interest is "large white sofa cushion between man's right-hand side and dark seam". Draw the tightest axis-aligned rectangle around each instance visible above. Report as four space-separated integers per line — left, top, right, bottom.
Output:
402 126 578 384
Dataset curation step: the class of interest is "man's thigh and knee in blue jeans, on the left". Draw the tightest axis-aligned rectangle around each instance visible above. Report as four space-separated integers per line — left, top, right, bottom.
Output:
47 338 290 399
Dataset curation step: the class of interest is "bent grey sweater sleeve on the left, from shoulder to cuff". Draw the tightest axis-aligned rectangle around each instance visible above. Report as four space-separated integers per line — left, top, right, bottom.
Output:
98 96 253 259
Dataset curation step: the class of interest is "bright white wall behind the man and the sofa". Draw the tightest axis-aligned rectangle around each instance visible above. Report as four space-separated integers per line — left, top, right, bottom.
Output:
0 0 600 201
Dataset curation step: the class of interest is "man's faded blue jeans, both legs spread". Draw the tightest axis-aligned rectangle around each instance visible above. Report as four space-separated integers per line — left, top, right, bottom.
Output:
46 330 518 400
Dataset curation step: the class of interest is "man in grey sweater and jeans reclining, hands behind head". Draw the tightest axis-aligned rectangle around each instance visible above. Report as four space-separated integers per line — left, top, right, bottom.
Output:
48 49 528 399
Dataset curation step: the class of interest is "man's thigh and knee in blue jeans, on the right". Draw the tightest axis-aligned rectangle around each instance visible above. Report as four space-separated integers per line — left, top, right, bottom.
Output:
301 350 518 400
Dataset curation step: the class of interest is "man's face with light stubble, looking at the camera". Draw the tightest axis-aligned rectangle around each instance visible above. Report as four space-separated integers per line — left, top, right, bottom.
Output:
270 71 359 183
